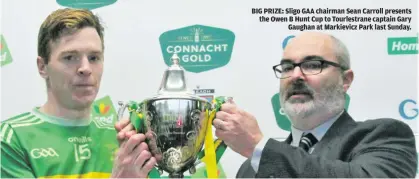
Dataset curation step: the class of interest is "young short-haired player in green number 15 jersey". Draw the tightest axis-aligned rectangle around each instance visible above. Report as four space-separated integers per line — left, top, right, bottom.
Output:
0 9 156 178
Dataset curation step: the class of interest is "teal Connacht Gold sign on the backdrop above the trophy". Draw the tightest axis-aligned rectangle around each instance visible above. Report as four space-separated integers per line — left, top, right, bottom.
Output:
159 25 235 73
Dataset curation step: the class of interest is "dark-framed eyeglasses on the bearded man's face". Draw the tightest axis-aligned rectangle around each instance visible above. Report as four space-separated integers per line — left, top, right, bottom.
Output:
272 56 345 79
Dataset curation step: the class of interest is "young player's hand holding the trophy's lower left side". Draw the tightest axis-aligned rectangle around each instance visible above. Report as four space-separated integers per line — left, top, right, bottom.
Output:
111 134 156 178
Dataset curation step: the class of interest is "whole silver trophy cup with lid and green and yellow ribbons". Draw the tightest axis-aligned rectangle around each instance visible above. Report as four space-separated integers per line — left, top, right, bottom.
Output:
118 54 230 178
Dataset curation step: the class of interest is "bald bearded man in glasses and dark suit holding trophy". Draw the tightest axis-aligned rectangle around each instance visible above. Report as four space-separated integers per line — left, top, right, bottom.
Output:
214 32 417 178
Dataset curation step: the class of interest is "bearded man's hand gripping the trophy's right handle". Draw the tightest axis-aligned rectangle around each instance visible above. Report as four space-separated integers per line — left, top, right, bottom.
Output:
213 102 263 158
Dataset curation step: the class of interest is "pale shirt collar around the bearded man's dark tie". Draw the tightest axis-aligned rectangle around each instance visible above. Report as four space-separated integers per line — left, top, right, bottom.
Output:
291 111 344 146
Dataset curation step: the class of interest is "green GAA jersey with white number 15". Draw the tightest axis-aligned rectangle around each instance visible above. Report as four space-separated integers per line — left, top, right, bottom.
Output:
1 108 118 178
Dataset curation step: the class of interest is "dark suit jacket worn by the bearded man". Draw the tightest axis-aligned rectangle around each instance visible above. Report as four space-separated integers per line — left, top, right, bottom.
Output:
236 111 417 178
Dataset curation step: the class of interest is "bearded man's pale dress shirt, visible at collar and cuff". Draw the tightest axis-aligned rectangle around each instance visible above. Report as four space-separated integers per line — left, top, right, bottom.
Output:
250 111 344 173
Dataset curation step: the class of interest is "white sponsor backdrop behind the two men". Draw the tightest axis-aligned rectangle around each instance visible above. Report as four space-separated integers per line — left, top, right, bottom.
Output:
0 0 418 177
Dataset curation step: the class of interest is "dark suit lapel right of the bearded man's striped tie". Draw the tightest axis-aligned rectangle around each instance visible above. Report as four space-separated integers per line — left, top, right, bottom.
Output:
312 110 356 154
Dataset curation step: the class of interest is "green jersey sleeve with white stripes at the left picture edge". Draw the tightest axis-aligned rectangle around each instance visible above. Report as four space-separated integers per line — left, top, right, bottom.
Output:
0 123 36 178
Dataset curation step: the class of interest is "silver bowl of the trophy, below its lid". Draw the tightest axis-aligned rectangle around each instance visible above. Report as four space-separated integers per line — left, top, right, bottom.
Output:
139 96 211 178
